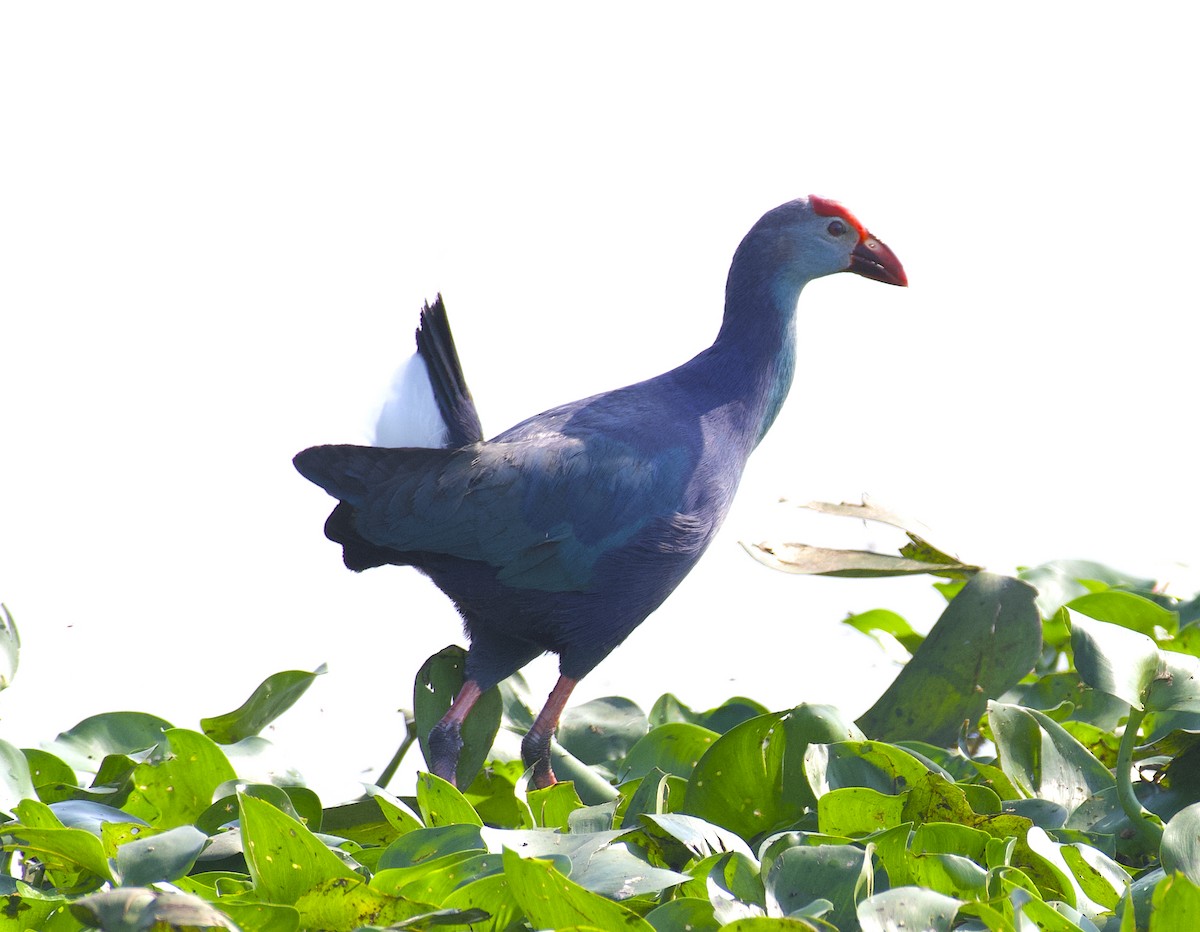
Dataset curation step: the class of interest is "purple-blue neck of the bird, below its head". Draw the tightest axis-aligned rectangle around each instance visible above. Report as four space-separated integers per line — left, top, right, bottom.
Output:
708 251 806 446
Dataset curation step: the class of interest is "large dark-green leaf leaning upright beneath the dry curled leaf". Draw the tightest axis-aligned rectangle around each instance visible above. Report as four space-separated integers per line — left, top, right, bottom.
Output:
857 573 1042 746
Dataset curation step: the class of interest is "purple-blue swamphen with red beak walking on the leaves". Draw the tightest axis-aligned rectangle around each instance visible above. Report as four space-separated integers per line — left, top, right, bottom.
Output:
293 194 907 788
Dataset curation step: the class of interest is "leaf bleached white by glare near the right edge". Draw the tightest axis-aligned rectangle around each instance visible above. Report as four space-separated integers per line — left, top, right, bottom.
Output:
1070 614 1159 711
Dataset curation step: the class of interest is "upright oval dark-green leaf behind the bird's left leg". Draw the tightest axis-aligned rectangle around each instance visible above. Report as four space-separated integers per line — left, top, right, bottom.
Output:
413 644 504 787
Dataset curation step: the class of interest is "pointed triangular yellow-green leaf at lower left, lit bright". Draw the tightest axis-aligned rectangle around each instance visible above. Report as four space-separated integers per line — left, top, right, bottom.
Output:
239 795 356 904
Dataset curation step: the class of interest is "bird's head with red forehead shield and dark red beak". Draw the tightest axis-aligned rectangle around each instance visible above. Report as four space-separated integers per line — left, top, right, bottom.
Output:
742 194 908 287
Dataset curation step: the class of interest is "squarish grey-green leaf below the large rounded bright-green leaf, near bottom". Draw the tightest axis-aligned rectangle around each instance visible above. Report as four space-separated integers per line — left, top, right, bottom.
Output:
763 844 875 928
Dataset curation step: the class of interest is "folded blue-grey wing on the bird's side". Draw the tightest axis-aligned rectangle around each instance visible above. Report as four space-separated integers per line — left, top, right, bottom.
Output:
295 431 689 591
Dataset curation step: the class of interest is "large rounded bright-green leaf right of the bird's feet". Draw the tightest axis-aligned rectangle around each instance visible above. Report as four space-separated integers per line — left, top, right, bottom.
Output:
683 704 860 838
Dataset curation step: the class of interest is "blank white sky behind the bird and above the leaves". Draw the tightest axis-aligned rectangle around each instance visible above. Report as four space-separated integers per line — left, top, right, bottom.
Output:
0 2 1200 793
